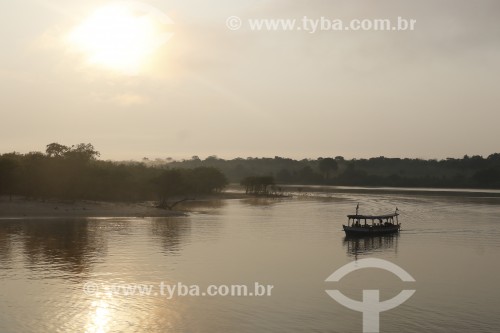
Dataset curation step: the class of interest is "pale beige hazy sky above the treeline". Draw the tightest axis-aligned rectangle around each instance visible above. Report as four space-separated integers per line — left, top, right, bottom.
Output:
0 0 500 159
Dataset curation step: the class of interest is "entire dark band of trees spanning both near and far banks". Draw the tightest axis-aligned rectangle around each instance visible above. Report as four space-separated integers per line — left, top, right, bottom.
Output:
0 143 500 204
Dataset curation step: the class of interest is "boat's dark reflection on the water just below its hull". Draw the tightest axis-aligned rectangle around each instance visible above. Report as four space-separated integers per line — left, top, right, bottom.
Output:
343 234 399 259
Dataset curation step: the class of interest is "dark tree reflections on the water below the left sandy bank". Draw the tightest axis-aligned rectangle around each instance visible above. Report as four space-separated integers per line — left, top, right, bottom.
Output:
0 217 197 277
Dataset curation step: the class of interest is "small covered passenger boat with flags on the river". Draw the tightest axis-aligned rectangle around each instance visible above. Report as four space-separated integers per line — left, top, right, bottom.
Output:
343 204 401 237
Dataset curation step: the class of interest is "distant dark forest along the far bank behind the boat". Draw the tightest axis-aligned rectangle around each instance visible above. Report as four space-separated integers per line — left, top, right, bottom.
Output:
164 154 500 189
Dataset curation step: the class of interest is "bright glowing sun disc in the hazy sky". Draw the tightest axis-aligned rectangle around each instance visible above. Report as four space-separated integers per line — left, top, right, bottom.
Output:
68 2 172 74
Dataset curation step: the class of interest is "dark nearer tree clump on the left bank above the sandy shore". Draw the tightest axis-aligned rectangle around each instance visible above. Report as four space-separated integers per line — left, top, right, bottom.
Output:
0 143 227 208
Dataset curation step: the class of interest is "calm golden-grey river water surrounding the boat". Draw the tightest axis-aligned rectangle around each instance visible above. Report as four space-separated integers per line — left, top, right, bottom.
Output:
0 188 500 333
